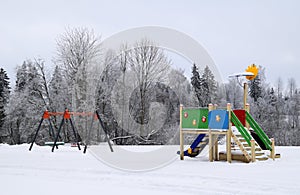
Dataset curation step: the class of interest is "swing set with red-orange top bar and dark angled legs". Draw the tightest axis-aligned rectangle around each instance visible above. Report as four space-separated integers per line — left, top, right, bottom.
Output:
29 109 113 153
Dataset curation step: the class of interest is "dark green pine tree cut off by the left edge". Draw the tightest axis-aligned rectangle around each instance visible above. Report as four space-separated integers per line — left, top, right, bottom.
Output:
0 68 10 143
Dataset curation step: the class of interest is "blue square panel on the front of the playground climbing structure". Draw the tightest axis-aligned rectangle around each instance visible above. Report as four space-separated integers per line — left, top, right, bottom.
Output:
208 110 229 129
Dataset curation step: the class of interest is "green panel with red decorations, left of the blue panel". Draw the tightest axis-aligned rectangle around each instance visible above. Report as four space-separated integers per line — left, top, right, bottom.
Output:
182 108 208 129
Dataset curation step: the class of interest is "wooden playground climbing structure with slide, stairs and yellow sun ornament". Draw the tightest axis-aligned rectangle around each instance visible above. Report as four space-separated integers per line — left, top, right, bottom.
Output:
179 64 280 162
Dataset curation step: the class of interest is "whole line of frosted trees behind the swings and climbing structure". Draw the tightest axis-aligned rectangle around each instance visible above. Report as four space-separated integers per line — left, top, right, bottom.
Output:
0 28 300 145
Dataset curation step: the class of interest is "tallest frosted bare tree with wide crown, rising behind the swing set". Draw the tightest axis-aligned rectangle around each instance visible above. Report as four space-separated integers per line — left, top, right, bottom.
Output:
55 28 100 140
